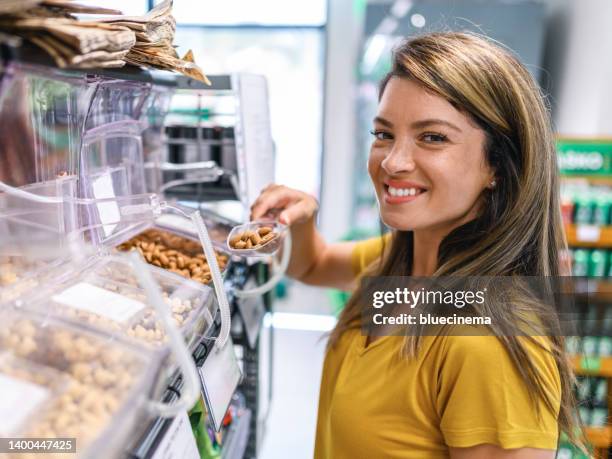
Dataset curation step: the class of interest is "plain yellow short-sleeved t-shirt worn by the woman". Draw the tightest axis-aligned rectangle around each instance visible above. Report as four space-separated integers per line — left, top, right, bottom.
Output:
315 239 561 459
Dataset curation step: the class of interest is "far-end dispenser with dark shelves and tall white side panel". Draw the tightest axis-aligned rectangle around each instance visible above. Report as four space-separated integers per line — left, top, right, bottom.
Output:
151 74 274 220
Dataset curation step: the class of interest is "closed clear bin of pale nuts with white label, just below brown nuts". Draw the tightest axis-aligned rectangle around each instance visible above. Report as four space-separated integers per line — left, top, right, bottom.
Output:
26 256 216 354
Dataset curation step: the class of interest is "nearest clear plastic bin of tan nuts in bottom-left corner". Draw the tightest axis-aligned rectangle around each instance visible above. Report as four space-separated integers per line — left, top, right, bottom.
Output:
0 309 159 459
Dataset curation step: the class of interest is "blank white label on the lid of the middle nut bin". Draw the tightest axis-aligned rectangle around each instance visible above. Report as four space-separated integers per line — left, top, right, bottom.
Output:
52 282 145 323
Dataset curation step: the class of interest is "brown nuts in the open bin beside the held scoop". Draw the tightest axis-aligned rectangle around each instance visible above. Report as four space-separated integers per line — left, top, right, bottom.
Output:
117 229 228 284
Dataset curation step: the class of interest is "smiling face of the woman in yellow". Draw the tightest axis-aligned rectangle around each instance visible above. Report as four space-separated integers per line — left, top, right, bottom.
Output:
368 77 494 233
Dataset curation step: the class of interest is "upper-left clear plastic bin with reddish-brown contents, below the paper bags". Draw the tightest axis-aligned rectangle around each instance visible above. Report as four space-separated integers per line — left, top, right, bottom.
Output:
0 62 96 187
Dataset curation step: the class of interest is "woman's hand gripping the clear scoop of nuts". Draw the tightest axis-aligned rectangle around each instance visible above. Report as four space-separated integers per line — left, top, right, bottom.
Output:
251 184 319 226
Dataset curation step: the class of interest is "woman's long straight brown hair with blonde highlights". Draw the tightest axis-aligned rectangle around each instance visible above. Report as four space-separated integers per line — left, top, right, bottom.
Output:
329 33 582 445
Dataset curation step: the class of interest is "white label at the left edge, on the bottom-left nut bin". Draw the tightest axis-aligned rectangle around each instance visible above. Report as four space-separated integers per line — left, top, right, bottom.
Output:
0 374 50 437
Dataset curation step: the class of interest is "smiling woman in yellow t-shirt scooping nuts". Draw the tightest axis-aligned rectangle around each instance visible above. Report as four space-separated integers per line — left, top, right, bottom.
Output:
252 33 575 459
